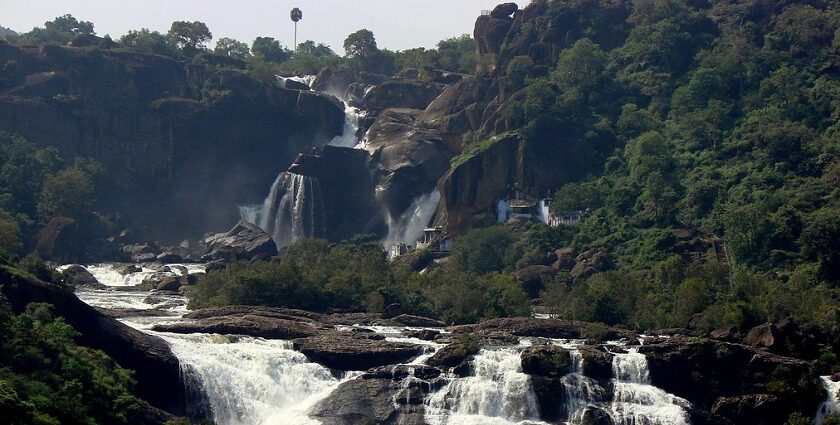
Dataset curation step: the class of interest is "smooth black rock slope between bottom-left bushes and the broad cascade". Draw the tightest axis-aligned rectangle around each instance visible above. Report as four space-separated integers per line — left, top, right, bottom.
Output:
0 270 185 414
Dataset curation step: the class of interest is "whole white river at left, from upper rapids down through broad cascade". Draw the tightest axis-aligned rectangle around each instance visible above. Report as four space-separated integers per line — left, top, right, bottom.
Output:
65 264 354 425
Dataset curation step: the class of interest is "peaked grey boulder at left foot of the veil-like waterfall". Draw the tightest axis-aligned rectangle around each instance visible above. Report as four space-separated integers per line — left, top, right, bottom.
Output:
202 221 277 261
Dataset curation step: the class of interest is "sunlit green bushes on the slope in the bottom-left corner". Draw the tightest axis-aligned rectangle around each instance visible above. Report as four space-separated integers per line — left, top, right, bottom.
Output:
0 298 142 424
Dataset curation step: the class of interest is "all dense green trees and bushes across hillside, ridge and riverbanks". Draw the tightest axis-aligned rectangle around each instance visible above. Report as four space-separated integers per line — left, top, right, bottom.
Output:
0 0 840 425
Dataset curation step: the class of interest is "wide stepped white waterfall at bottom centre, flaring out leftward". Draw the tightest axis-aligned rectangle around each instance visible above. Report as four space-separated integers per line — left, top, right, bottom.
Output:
426 348 539 425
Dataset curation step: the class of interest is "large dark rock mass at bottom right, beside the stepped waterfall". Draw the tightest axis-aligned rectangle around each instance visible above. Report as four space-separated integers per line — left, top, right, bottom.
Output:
639 337 824 424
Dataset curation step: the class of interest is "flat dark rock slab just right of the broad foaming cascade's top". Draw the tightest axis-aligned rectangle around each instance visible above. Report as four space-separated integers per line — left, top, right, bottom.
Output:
294 332 423 370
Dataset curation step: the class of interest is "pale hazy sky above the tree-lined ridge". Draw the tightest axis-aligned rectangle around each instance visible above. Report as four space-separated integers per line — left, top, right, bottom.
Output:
0 0 530 54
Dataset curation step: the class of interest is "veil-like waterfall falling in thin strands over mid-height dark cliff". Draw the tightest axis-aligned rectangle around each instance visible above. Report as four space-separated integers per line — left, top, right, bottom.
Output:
258 172 326 247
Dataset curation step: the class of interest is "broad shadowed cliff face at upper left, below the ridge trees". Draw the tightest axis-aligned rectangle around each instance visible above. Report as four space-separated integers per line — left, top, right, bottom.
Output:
0 44 344 241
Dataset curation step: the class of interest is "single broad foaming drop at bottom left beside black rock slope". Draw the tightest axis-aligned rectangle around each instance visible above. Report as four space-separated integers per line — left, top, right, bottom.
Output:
159 334 340 425
